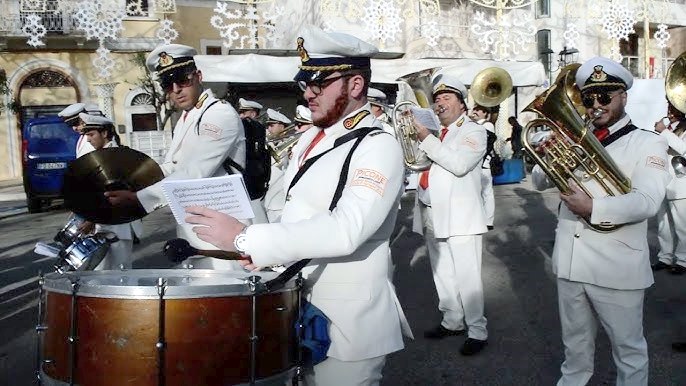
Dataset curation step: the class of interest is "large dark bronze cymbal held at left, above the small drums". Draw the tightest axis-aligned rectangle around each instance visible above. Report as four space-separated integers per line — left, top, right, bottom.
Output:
62 147 164 224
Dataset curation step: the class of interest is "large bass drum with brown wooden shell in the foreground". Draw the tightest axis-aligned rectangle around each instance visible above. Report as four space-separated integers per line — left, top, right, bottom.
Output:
39 269 300 386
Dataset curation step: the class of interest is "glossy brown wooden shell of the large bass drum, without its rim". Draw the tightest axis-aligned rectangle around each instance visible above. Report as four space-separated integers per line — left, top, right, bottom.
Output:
43 272 298 386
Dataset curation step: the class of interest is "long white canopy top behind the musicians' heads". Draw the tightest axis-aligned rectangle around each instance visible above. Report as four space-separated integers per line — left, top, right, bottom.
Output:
195 54 548 87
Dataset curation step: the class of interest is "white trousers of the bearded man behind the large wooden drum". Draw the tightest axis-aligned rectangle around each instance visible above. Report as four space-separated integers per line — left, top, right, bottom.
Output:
305 355 386 386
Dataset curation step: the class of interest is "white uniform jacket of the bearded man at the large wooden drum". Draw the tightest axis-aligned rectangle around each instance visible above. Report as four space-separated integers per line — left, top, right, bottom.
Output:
246 104 404 361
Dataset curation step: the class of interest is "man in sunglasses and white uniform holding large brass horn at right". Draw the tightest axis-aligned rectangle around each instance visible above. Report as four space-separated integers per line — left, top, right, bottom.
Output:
532 57 671 386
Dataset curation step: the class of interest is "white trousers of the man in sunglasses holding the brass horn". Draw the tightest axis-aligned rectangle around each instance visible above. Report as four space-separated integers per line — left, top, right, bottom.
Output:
557 278 648 386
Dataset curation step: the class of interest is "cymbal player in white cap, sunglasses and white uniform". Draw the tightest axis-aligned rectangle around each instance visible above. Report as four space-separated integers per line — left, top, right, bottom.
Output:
105 44 250 269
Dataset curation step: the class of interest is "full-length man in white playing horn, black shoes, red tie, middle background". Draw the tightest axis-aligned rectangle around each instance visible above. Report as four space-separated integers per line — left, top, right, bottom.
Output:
415 74 488 355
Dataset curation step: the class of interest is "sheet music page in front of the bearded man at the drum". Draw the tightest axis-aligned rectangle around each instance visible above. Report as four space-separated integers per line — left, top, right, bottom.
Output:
162 174 255 225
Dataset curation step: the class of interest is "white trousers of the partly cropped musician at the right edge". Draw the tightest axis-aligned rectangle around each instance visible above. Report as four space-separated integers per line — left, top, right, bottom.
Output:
657 199 686 267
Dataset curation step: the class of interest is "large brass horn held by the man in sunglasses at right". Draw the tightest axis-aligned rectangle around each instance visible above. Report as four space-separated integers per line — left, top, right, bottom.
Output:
521 63 631 232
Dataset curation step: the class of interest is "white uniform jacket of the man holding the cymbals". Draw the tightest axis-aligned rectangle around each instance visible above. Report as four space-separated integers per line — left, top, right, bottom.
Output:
137 90 245 249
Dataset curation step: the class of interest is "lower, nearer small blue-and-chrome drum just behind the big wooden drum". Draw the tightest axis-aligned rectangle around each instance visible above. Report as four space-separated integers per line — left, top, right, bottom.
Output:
55 234 111 273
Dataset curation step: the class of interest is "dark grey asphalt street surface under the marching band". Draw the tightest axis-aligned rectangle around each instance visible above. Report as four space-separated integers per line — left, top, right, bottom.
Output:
0 176 686 386
